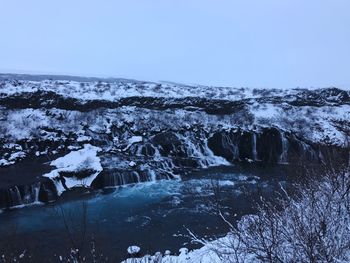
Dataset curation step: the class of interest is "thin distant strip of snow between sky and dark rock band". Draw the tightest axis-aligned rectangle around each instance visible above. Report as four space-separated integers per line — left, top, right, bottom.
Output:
0 80 296 101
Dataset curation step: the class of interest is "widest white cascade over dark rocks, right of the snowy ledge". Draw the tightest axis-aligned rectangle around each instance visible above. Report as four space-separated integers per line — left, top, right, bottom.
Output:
94 131 229 188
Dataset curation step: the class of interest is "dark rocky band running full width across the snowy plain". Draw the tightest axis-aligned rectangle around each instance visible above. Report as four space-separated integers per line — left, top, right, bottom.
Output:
0 88 350 115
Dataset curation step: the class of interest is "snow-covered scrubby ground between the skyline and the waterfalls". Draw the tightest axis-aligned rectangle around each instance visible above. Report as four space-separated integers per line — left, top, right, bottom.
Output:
0 77 350 148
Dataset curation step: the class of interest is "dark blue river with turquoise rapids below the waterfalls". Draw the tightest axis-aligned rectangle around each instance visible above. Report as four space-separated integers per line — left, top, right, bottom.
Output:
0 166 286 261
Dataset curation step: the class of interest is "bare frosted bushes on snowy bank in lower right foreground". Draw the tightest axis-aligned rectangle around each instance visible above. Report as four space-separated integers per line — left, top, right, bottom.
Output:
125 168 350 263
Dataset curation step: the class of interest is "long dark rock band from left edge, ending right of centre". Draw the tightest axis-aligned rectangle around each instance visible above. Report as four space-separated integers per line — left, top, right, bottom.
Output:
0 91 245 114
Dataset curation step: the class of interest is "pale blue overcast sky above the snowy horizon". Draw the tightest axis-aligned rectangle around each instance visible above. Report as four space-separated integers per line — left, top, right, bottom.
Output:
0 0 350 88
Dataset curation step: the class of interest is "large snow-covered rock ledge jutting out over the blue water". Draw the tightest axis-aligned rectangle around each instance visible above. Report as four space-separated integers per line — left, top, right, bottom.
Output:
43 144 103 195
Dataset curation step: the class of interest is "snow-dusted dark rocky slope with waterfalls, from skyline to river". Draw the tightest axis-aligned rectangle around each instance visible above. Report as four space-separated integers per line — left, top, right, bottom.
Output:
0 76 350 208
